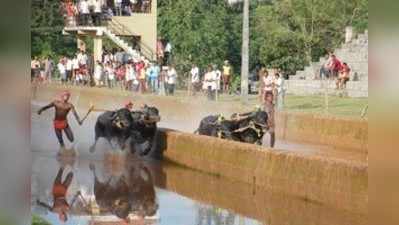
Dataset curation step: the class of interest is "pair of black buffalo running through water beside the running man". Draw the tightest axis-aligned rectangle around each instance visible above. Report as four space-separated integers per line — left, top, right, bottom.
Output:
90 105 160 156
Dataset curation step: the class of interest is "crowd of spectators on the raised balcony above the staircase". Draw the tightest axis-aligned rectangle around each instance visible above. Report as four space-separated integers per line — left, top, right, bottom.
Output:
62 0 151 26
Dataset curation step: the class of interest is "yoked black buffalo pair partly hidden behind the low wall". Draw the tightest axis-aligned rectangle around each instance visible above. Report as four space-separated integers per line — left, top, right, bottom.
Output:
195 109 269 145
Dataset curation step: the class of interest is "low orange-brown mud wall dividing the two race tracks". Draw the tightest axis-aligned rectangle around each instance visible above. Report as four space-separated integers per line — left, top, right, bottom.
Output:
159 130 368 213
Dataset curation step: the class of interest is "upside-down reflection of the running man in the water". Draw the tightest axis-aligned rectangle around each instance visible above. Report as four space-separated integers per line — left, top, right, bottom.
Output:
36 167 81 222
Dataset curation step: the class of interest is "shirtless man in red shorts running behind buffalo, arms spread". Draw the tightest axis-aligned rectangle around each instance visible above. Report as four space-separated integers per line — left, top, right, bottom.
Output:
37 91 84 148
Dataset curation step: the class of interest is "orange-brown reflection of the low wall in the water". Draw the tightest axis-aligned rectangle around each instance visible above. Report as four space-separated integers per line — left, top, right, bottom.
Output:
157 164 367 225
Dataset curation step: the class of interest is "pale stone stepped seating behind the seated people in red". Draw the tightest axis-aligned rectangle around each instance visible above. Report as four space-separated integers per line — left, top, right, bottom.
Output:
286 31 368 97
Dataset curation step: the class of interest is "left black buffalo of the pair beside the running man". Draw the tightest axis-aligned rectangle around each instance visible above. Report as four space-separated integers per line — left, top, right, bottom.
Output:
90 108 133 152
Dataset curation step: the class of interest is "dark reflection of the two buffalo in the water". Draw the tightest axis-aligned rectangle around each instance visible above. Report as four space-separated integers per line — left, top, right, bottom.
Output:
86 162 158 220
